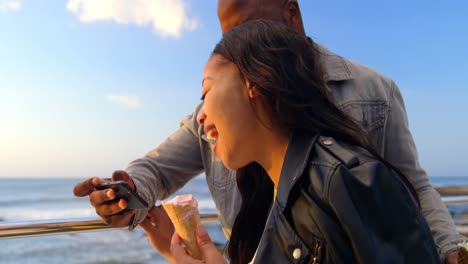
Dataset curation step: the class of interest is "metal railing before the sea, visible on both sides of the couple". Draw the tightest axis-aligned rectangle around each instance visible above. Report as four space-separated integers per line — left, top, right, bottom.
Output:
0 186 468 240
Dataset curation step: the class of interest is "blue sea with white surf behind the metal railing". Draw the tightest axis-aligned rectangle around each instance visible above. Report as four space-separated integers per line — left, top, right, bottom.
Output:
0 175 468 264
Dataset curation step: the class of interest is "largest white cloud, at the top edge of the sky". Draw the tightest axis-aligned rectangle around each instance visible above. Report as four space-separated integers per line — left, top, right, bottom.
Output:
66 0 198 38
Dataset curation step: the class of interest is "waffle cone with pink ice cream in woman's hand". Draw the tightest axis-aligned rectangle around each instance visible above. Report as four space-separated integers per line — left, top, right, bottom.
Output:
162 194 202 260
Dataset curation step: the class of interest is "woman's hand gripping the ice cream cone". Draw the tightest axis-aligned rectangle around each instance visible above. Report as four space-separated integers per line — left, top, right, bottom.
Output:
171 224 227 264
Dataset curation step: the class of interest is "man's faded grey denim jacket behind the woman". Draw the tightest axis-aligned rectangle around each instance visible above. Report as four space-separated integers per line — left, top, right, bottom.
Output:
126 46 465 260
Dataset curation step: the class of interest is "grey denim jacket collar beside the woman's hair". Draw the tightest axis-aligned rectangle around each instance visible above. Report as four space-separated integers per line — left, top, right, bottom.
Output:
314 42 354 82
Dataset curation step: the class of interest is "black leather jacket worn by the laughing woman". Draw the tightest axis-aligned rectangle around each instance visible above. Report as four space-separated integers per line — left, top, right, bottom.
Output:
254 132 440 264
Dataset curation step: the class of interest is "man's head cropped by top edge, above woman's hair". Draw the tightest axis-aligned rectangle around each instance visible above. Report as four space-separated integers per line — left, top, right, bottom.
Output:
218 0 305 35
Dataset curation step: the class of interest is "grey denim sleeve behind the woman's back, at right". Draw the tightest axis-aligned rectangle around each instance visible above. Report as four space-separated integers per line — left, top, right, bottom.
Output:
383 82 466 261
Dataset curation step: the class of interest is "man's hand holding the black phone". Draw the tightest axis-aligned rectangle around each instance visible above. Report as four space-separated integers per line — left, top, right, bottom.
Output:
73 171 136 227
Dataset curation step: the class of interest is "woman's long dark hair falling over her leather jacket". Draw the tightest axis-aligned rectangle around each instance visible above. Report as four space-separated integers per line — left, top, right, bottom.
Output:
213 20 419 263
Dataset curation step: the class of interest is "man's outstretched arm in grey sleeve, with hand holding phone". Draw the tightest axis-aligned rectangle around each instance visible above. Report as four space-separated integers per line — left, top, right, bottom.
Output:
73 104 203 229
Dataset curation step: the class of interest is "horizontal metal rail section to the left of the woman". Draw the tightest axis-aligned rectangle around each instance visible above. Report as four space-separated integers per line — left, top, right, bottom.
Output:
0 213 218 240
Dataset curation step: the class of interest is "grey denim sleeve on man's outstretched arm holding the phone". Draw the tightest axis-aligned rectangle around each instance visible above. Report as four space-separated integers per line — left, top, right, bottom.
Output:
125 104 203 229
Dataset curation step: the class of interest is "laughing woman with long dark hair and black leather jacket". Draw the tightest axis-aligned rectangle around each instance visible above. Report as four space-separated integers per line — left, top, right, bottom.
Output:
145 20 439 263
